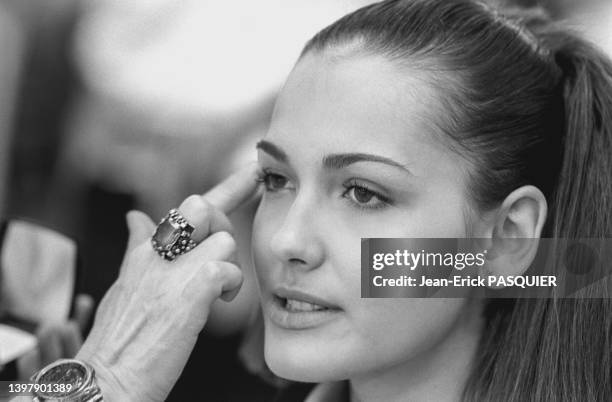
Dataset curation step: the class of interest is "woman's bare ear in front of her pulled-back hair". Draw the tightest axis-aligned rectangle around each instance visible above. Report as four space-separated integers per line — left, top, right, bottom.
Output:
485 186 548 282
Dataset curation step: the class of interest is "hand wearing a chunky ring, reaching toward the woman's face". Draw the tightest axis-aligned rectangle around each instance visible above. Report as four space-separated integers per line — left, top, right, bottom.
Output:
76 164 258 402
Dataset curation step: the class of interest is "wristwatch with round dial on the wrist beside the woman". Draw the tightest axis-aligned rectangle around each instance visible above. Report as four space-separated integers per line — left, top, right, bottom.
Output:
30 359 103 402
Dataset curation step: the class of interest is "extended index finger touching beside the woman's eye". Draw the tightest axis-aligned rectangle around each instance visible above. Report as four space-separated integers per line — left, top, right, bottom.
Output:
202 162 260 214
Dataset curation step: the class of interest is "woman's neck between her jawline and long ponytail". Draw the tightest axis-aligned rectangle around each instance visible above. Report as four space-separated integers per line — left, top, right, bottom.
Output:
350 300 483 402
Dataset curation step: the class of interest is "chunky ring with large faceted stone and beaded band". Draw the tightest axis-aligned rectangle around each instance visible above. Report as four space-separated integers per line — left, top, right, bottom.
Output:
151 209 197 261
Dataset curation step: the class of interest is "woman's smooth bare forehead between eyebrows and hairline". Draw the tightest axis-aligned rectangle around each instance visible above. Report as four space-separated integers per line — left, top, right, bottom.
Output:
266 54 454 173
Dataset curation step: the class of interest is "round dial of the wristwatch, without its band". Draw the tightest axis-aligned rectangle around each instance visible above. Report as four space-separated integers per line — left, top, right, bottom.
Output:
37 363 87 398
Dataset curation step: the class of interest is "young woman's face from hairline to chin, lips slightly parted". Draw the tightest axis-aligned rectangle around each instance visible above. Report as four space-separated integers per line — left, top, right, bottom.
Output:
253 54 476 382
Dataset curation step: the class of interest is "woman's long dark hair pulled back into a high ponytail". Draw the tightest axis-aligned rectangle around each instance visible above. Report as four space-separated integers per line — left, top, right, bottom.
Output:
302 0 612 402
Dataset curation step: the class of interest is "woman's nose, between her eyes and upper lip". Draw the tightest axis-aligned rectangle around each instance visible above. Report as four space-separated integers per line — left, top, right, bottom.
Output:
270 199 325 269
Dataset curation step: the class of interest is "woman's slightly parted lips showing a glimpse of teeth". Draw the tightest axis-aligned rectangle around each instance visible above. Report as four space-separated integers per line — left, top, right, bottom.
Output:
266 288 342 330
